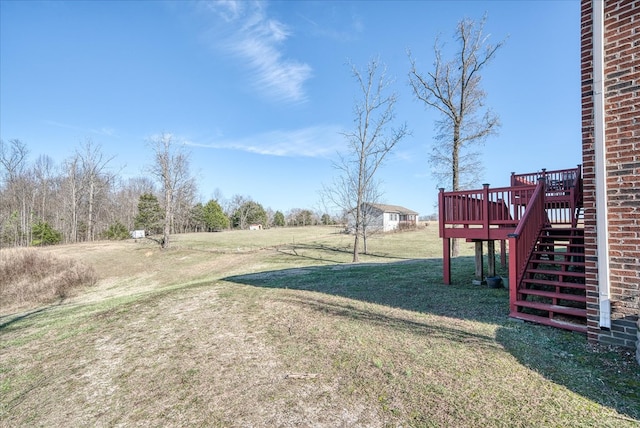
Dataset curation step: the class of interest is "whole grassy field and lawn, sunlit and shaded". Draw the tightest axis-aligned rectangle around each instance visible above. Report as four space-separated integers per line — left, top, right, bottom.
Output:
0 226 640 427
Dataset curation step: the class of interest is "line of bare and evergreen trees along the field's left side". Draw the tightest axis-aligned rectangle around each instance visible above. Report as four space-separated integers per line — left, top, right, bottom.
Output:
0 140 335 247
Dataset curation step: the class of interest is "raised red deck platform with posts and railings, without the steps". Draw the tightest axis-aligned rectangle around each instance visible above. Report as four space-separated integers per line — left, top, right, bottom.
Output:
438 165 582 287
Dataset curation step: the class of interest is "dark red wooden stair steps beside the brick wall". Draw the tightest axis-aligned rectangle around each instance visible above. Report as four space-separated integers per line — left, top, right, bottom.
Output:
511 226 587 333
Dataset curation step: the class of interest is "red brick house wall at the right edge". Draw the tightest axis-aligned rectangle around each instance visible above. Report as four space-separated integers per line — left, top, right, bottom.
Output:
581 0 640 352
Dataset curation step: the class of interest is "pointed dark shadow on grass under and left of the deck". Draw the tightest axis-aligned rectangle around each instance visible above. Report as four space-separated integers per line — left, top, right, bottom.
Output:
224 257 509 322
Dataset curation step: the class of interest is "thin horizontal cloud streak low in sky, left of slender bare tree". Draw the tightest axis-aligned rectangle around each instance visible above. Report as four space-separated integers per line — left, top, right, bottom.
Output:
186 126 344 158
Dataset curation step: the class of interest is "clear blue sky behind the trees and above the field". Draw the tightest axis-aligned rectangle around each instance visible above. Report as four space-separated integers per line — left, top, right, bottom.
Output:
0 0 581 215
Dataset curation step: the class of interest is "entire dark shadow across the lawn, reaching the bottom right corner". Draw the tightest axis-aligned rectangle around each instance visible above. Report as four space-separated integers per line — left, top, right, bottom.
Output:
224 257 640 422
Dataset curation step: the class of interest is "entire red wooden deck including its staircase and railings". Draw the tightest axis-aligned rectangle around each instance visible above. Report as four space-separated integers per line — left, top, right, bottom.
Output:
438 165 586 331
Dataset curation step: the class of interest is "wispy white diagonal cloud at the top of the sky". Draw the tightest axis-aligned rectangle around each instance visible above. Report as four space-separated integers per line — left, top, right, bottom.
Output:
200 0 312 102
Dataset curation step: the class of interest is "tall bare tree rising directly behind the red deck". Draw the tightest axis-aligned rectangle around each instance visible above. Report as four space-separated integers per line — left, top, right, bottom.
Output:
409 17 504 256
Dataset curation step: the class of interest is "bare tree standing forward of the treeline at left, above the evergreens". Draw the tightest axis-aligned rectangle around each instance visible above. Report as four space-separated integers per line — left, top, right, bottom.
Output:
149 132 193 248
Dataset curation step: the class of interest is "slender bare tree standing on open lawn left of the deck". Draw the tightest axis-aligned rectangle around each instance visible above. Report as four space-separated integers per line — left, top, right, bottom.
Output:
322 58 407 262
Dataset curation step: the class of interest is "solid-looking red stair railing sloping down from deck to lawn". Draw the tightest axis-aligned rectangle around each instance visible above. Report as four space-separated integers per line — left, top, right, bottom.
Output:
509 177 547 313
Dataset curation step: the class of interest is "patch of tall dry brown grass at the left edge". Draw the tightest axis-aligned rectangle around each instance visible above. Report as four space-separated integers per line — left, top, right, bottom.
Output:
0 248 98 313
